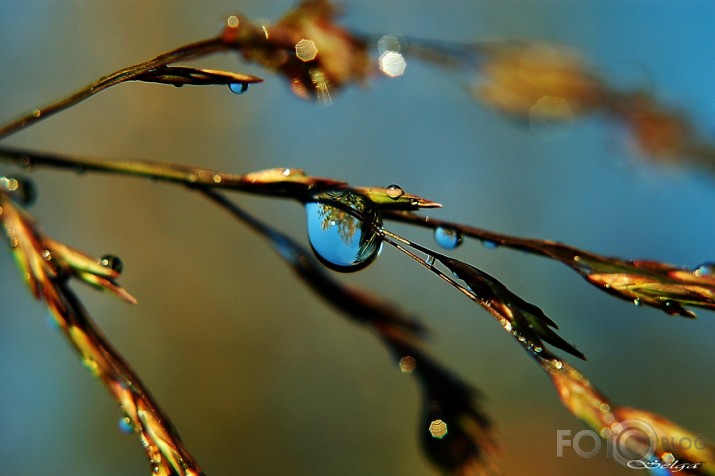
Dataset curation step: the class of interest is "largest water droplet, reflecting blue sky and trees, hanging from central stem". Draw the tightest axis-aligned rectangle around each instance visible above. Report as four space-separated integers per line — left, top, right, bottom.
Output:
305 190 382 272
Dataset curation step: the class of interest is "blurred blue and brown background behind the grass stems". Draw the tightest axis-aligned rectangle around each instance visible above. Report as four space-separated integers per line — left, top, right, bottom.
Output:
0 0 715 476
